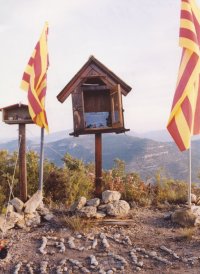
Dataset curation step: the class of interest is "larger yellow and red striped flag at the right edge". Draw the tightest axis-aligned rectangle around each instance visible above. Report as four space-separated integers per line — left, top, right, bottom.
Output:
167 0 200 151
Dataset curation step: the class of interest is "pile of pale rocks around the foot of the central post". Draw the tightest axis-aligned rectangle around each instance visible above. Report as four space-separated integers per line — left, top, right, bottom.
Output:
69 190 130 219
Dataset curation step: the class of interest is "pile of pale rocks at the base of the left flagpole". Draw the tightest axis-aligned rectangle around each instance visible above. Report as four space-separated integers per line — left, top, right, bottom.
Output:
0 190 53 232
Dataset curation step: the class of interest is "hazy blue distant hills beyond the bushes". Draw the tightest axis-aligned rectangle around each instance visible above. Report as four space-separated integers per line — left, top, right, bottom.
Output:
0 134 200 182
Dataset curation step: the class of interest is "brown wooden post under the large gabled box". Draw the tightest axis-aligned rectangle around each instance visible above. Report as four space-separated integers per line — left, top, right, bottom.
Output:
95 133 102 197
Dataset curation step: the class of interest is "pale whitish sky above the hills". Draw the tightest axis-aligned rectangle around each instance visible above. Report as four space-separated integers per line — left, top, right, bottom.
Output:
0 0 200 139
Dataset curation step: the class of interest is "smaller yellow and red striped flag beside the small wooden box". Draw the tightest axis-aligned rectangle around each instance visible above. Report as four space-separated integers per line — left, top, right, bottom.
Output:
21 23 49 131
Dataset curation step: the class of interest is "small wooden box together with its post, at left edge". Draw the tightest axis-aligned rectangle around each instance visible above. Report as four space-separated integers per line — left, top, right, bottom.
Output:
0 103 33 202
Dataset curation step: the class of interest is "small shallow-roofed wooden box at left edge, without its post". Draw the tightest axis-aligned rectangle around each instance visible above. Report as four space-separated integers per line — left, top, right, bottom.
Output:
0 103 33 124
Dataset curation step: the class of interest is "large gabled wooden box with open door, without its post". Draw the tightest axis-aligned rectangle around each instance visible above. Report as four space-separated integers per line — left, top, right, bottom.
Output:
57 56 131 136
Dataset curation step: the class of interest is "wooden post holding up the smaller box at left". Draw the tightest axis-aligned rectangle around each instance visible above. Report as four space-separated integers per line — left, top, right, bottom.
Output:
19 123 27 202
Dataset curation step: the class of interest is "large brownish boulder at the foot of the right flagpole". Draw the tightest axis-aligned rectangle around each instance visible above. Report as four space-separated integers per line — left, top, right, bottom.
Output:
171 208 197 227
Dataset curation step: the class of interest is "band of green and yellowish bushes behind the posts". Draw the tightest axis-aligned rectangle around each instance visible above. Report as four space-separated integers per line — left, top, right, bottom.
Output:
0 150 199 210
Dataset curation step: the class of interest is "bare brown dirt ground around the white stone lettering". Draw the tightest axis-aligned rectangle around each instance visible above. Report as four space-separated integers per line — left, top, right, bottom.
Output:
0 208 200 274
